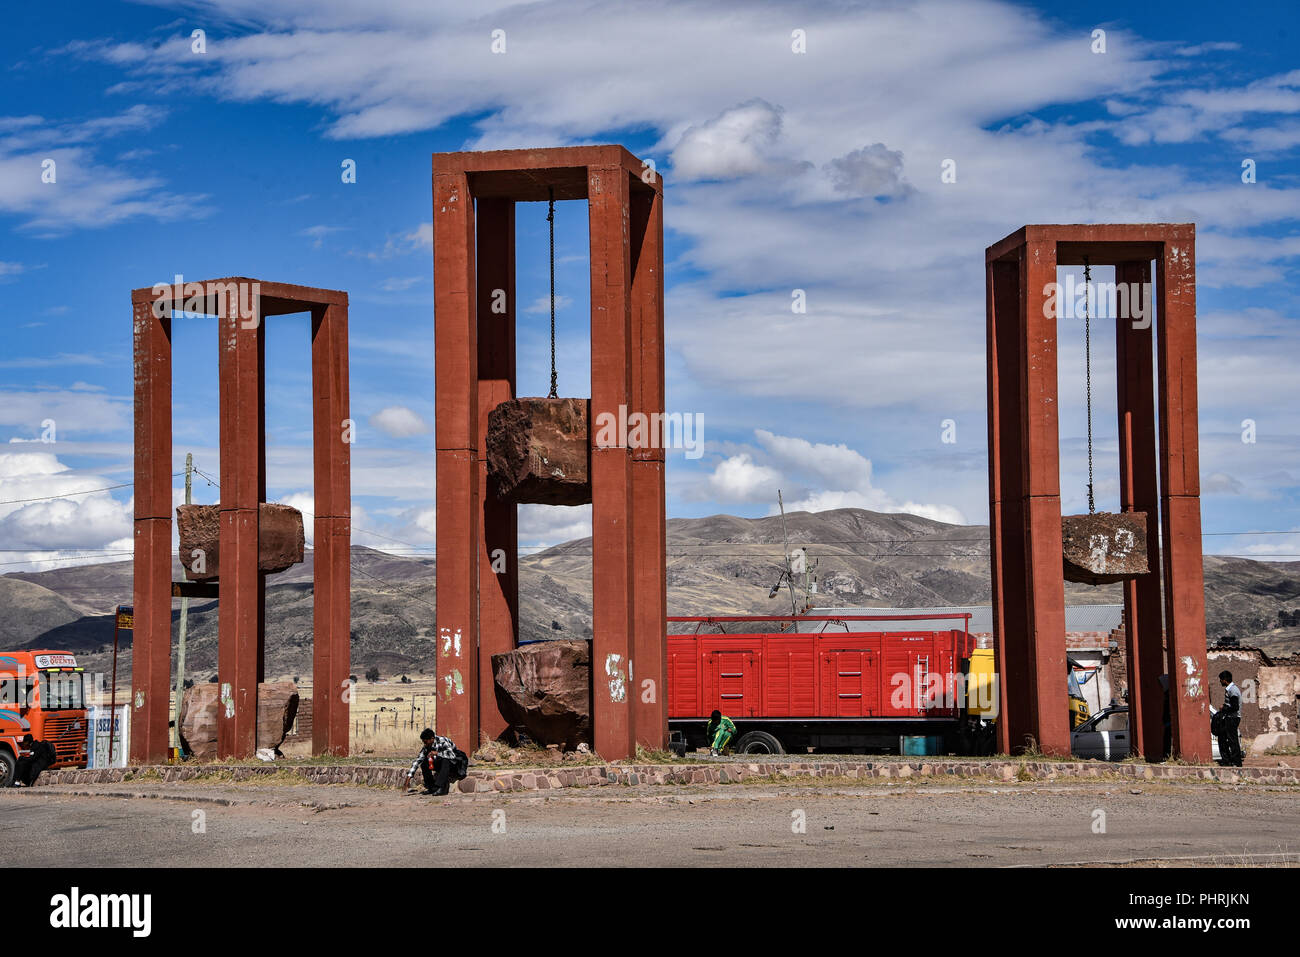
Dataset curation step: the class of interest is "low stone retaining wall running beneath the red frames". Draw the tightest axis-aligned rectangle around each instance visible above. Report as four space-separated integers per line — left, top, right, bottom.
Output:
36 761 1300 793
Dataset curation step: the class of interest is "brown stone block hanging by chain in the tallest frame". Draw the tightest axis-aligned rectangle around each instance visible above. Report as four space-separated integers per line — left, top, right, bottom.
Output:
486 398 592 505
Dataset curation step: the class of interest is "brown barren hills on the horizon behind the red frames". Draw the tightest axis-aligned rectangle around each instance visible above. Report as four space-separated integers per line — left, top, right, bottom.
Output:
0 508 1300 680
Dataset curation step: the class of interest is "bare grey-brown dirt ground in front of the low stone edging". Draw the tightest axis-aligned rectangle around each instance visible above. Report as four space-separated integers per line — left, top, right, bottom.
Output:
0 781 1300 867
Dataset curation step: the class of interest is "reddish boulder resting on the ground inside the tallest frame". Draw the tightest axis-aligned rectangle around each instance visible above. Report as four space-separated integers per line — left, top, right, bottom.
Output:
491 640 592 750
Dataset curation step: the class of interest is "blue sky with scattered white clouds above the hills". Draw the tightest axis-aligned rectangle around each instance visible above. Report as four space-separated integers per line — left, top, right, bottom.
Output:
0 0 1300 571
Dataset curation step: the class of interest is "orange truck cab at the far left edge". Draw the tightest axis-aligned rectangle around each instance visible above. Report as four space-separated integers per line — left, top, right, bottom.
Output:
0 650 87 787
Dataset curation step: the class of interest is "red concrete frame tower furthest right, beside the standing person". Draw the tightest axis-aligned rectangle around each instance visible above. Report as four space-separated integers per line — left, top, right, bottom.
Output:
985 224 1210 761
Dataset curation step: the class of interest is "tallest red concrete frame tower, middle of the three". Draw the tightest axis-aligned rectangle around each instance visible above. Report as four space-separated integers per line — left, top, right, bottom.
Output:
433 146 668 759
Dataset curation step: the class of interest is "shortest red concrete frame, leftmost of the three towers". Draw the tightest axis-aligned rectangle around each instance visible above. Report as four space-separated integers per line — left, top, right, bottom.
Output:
130 277 351 763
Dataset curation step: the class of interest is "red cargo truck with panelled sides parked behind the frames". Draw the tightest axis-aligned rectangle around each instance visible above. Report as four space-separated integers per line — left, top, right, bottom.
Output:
668 614 997 754
